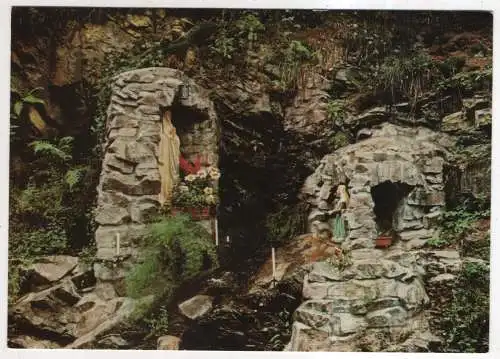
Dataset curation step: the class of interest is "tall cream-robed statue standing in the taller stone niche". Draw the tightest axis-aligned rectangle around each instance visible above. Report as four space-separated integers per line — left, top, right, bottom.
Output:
158 111 180 205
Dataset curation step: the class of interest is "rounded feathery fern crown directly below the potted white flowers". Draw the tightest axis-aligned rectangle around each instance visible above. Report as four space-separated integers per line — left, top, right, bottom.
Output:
126 215 217 298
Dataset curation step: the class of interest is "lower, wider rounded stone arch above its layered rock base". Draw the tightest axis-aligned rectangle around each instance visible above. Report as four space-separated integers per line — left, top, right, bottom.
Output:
301 124 451 249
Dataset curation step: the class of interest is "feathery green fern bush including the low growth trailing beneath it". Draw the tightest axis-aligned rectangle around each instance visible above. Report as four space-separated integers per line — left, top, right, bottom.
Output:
126 214 218 336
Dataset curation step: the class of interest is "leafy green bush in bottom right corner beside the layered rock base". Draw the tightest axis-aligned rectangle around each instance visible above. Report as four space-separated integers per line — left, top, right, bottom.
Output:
440 263 490 353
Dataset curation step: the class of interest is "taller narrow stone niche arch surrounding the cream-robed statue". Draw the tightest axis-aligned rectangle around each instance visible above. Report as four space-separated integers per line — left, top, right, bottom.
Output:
94 68 219 296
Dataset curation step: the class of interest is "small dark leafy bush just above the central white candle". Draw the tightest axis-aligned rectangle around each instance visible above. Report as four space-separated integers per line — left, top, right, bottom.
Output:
265 204 307 245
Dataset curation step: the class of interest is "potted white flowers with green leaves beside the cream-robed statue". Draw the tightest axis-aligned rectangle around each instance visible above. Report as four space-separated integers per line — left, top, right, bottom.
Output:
172 156 220 220
